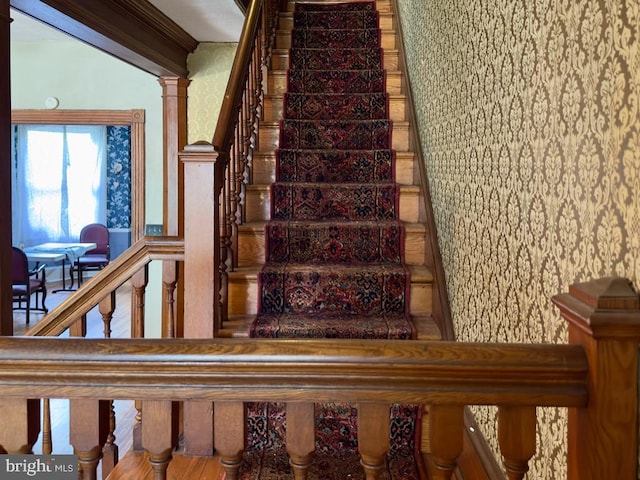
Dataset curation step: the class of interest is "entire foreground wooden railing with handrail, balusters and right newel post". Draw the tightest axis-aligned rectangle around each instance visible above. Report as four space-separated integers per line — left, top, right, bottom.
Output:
0 278 640 480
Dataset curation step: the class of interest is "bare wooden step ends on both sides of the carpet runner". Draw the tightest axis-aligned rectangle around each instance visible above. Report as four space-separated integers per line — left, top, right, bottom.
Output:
220 0 442 340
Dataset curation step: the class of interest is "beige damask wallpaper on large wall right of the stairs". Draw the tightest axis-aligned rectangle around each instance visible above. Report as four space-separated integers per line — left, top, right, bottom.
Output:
398 0 640 479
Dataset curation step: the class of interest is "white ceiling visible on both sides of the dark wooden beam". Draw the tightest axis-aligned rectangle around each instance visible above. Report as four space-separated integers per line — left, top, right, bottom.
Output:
10 0 244 43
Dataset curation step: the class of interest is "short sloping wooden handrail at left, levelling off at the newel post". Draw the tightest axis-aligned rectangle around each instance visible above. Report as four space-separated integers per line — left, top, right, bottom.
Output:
24 237 184 336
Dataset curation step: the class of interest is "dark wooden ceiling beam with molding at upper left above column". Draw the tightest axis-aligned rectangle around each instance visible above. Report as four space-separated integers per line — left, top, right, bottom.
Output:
10 0 198 77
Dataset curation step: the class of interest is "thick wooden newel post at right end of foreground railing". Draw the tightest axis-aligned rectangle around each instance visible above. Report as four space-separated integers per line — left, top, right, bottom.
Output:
552 277 640 480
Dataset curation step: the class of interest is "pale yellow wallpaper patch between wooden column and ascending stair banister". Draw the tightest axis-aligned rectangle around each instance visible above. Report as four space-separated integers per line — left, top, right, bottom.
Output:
187 43 237 143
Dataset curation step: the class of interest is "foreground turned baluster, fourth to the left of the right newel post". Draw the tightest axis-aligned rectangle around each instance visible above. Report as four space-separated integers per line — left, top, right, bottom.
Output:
287 403 315 480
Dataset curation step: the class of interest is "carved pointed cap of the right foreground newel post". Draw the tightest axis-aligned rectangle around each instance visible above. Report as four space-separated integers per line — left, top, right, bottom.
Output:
552 277 640 341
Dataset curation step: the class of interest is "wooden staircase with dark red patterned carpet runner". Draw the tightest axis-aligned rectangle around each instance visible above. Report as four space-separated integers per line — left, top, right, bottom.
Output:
221 0 441 480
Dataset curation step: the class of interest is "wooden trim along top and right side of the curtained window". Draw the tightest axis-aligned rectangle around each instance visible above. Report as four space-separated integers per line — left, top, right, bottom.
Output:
11 109 145 242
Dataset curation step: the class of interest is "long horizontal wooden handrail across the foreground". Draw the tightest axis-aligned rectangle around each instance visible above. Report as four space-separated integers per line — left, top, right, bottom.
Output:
0 337 587 407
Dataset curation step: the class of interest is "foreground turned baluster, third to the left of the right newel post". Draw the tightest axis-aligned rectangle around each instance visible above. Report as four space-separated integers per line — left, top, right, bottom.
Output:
358 403 390 480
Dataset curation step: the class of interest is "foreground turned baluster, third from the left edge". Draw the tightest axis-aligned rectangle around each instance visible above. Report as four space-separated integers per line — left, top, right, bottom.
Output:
142 400 178 480
